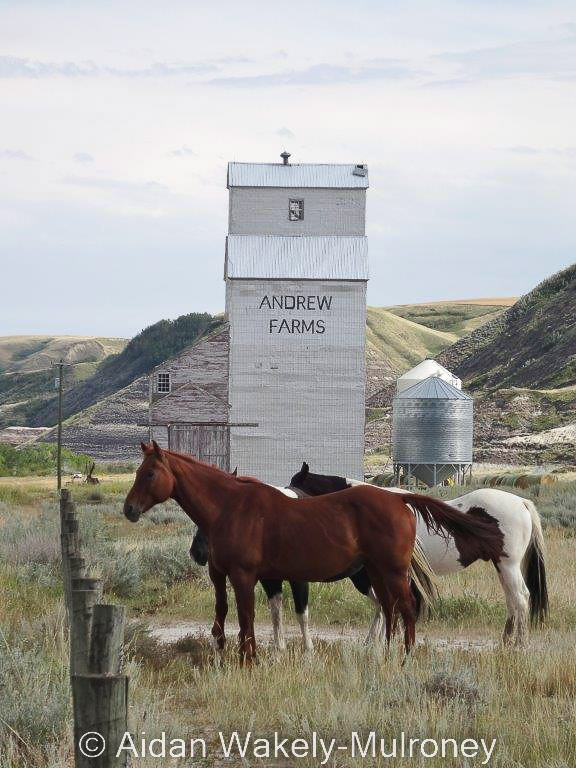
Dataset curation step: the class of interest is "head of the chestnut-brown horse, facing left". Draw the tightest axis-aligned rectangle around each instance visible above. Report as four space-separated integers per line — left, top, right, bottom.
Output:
124 440 176 523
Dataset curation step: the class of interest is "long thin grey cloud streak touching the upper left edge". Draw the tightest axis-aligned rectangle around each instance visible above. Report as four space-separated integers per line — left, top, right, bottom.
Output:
0 56 219 79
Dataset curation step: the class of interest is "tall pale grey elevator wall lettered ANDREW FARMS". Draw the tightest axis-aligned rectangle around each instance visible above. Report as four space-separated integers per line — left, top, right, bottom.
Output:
227 280 366 484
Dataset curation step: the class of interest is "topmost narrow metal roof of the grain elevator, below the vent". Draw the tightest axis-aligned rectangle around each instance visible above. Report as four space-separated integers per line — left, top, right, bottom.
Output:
227 163 368 189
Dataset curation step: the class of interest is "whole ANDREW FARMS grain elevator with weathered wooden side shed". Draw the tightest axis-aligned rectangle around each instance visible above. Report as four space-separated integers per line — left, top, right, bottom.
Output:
150 153 368 484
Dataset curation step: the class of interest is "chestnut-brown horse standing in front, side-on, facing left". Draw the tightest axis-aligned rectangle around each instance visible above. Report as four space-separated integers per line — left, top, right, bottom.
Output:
124 442 502 660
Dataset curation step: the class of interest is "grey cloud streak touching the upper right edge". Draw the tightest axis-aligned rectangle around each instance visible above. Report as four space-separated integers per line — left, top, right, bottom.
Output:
434 32 576 80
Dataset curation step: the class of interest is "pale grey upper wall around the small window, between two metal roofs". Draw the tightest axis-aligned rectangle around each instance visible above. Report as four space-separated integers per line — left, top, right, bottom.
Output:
228 187 366 235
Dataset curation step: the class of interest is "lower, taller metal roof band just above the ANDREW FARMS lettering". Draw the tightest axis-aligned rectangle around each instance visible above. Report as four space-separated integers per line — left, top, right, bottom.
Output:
224 235 368 280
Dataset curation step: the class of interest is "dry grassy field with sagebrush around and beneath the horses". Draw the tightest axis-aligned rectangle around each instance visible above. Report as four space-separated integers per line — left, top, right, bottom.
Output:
0 476 576 768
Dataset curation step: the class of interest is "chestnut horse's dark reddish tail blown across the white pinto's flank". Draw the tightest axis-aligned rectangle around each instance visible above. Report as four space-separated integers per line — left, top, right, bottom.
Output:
402 493 504 567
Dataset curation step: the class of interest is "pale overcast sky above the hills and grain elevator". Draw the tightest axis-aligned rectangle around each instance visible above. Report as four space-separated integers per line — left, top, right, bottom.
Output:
0 0 576 337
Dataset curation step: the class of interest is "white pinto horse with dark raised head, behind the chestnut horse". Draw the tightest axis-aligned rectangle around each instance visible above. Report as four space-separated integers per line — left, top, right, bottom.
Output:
289 462 548 646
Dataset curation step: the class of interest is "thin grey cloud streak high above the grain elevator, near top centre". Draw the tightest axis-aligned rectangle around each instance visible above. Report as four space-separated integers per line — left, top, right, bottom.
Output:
205 59 417 88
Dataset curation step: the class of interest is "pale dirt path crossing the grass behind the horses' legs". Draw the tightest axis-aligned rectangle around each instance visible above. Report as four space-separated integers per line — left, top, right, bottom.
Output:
150 621 498 651
